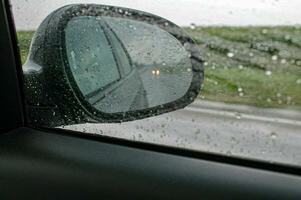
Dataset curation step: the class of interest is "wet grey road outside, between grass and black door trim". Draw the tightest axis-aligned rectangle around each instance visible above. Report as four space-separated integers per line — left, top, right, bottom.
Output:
65 101 301 166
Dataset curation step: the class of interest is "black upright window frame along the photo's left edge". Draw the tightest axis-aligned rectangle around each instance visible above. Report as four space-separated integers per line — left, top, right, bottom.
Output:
0 0 26 133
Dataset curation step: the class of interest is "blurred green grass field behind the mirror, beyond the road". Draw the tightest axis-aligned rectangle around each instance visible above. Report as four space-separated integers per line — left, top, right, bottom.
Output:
18 27 301 109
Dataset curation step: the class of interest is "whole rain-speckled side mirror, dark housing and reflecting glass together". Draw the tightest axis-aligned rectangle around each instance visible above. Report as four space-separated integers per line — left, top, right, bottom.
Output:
23 4 204 127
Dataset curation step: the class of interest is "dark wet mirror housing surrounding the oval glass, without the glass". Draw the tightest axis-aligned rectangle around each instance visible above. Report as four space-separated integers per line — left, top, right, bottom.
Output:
23 4 204 127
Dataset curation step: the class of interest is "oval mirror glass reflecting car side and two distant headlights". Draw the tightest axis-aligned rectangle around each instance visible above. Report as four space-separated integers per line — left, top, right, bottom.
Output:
65 16 193 113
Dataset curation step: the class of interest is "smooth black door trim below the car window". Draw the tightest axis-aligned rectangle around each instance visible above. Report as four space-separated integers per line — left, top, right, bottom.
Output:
0 128 301 200
